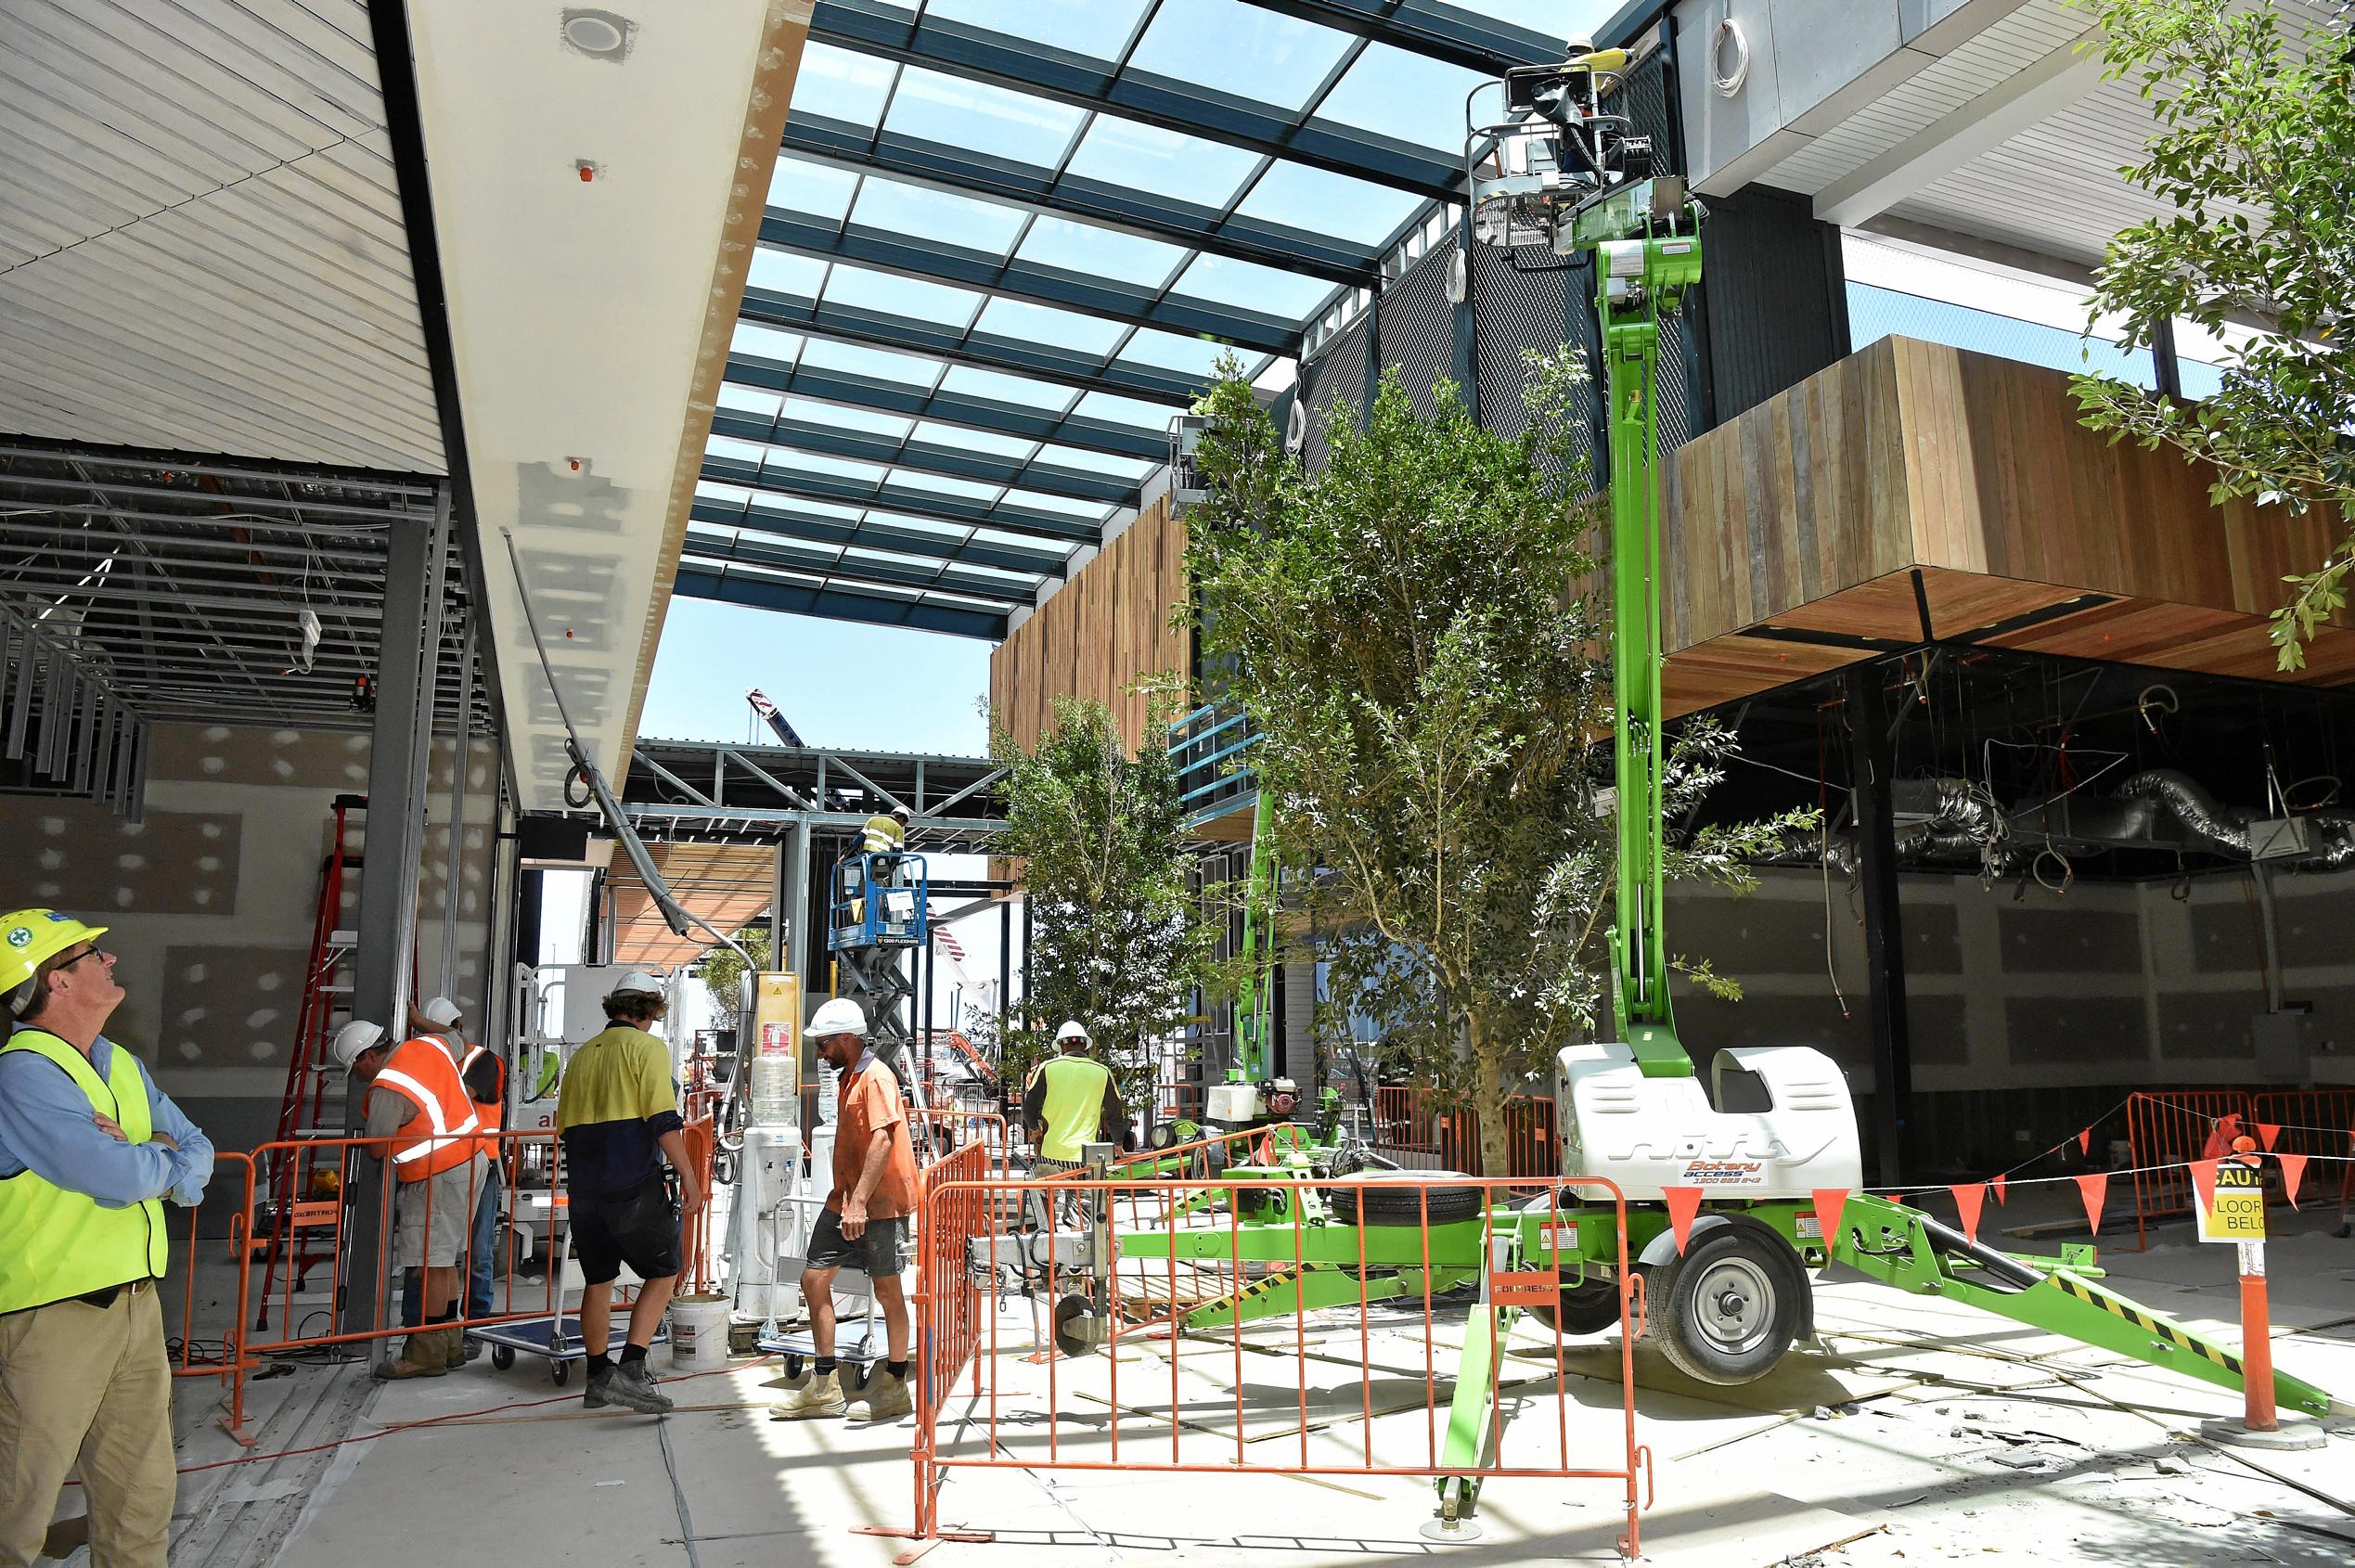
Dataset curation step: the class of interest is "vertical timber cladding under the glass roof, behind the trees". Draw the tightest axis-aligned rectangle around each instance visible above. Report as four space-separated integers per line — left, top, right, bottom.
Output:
989 496 1187 749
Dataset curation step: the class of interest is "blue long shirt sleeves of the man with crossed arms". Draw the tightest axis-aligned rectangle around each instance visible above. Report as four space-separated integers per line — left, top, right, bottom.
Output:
0 1034 212 1208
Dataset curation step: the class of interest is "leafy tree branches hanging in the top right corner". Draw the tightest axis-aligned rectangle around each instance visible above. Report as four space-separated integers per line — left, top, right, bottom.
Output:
2075 0 2355 669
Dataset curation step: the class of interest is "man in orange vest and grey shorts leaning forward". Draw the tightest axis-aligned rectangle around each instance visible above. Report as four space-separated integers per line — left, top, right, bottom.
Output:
332 1020 487 1377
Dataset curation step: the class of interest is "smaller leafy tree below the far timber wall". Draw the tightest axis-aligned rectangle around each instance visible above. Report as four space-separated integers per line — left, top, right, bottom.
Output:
991 692 1217 1095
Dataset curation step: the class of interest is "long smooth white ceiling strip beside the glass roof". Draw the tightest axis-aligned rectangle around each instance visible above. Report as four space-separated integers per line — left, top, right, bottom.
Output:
407 0 808 810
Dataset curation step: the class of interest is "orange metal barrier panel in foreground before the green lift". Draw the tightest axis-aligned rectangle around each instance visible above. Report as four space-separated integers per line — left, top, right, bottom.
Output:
859 1167 1651 1563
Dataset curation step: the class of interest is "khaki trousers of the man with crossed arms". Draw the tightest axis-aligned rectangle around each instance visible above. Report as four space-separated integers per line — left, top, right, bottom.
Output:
0 1283 179 1568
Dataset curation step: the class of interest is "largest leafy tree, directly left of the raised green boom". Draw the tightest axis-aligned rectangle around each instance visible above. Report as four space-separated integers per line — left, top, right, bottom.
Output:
1187 351 1782 1173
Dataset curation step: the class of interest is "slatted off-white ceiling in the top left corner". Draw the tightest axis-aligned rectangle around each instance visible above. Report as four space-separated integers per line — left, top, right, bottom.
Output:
0 0 443 473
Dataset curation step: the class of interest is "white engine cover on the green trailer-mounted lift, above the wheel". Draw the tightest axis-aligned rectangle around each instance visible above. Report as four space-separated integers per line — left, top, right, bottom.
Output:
1554 1046 1865 1201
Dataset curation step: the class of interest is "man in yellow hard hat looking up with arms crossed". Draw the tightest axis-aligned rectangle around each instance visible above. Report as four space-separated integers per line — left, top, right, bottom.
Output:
0 908 212 1568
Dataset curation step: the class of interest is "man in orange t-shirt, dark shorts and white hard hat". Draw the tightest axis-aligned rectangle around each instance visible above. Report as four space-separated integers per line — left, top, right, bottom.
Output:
770 996 916 1422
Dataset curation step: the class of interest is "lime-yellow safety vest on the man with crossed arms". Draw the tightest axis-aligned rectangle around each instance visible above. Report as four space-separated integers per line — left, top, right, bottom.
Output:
0 1029 172 1314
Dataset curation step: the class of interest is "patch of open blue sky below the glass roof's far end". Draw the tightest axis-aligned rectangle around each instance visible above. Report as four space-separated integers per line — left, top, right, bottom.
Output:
638 598 989 756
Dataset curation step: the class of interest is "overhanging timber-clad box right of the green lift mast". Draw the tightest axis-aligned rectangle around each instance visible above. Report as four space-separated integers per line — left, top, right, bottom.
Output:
1663 337 2355 711
